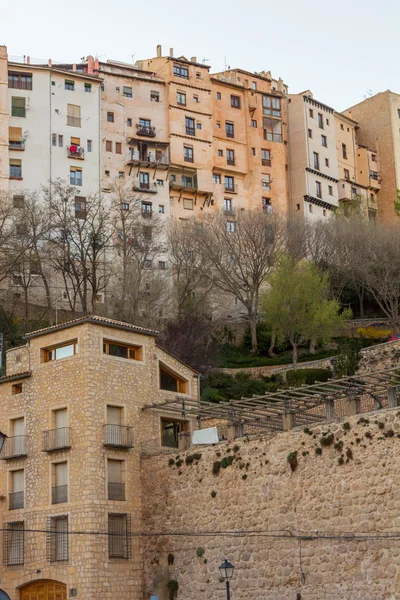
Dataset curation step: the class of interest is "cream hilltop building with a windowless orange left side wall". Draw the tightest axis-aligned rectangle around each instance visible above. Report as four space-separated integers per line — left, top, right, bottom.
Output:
288 90 339 221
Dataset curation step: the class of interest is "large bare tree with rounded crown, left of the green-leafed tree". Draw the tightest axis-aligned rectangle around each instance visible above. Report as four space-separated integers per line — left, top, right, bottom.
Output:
197 210 283 352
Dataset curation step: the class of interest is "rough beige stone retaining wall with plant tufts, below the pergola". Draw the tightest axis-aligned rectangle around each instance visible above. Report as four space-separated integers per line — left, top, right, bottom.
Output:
142 409 400 600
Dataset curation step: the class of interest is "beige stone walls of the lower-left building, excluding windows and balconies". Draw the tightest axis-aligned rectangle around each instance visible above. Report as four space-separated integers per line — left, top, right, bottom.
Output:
0 323 198 600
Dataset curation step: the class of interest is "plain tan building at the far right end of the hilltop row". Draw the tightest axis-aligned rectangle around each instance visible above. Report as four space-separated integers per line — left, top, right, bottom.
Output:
343 90 400 223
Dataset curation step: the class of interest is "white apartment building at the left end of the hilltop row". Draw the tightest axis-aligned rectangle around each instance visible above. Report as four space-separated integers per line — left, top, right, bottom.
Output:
0 51 101 197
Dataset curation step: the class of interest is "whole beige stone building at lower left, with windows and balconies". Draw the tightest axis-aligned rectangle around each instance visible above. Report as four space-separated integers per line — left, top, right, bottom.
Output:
0 316 199 600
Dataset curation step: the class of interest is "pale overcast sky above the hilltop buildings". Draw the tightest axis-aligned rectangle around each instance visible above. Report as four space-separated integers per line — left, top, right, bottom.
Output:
0 0 400 110
